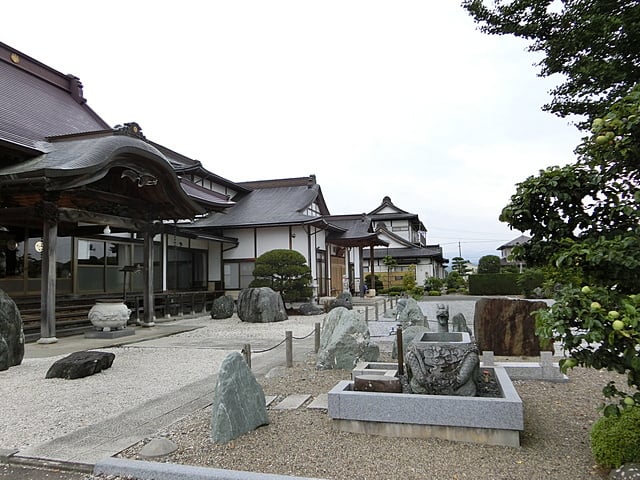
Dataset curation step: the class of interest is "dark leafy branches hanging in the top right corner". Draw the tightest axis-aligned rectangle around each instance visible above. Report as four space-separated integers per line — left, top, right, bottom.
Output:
462 0 640 124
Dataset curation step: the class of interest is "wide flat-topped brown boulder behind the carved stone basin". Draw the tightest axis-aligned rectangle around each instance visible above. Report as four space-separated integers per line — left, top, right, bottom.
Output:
473 298 553 357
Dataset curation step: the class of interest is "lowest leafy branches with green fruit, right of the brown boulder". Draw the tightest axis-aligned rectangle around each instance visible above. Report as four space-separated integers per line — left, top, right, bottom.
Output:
535 286 640 415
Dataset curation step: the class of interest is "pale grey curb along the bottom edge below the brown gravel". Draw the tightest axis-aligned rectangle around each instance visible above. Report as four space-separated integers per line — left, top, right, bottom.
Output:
93 458 322 480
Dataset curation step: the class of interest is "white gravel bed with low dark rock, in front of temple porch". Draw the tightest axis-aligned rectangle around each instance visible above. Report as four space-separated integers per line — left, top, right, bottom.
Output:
0 315 324 450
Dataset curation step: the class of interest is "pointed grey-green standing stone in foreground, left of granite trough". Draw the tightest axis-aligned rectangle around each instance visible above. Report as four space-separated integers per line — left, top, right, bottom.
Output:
211 352 269 443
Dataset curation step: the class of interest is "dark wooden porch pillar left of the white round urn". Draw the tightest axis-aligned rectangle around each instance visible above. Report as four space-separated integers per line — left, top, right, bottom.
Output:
38 215 58 343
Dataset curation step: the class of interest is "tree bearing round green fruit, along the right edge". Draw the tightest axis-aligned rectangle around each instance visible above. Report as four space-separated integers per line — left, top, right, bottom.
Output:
500 87 640 415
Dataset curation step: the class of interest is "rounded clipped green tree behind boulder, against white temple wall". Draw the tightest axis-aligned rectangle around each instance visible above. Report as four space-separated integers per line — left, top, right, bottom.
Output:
249 250 313 302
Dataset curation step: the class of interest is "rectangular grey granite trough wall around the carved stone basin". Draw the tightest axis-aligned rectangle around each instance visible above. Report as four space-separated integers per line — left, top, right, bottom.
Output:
328 362 524 447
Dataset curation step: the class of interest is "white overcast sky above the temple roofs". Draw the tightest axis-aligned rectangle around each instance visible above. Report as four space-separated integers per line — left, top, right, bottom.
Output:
0 0 582 262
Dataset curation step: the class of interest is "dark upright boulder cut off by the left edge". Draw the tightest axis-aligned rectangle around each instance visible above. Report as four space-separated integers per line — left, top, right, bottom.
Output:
0 290 24 371
